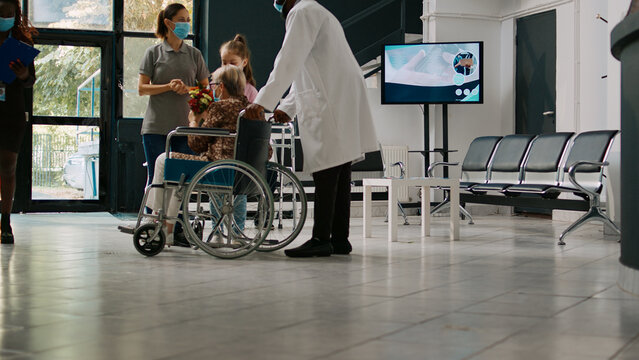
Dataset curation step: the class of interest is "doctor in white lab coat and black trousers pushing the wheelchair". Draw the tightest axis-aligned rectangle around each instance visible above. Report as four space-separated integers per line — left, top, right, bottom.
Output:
246 0 378 257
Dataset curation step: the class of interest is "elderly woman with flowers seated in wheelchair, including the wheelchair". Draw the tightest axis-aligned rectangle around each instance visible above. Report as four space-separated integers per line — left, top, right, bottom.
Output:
133 65 306 258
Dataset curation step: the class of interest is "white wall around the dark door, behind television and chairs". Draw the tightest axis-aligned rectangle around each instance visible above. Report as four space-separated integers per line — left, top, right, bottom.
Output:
372 0 630 220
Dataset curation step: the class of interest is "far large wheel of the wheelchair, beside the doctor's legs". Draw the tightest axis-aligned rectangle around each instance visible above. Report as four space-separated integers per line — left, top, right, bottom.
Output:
257 162 307 251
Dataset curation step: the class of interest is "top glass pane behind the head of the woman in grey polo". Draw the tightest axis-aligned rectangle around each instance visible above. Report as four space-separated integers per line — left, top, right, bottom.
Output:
124 0 193 33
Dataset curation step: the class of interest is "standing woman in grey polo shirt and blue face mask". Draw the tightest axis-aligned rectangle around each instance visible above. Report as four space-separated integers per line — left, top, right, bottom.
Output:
138 3 209 191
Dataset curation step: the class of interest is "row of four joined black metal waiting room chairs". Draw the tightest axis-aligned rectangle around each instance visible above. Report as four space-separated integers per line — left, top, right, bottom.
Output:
428 130 620 245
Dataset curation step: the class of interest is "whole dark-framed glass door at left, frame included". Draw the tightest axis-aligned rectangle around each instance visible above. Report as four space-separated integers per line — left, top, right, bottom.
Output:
16 39 107 211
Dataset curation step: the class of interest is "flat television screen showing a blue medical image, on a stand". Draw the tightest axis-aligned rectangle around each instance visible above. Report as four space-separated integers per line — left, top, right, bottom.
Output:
382 41 484 104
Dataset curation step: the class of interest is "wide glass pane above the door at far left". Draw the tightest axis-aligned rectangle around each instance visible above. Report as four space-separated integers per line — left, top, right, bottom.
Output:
28 0 113 30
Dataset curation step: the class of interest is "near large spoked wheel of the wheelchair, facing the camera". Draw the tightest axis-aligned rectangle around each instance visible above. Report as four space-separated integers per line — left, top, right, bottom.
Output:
182 160 273 259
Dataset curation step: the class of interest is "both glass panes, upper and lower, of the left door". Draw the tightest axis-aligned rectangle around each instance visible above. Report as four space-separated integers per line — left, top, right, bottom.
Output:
31 45 101 200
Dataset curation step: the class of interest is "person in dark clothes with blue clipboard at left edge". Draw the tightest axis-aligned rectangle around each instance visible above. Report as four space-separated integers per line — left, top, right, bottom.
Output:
0 0 38 244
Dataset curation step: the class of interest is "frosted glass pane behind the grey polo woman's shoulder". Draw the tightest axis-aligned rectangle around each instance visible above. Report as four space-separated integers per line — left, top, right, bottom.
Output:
122 37 193 118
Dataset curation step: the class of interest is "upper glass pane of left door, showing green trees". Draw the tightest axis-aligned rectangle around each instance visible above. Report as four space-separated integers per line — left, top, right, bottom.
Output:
33 45 101 117
